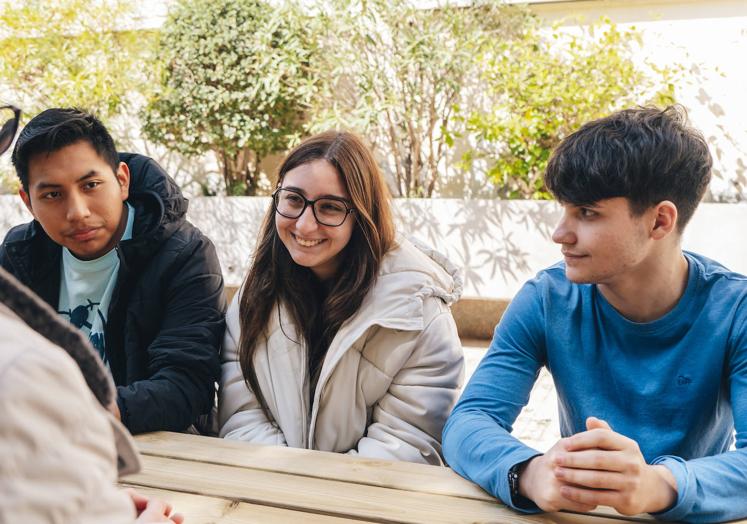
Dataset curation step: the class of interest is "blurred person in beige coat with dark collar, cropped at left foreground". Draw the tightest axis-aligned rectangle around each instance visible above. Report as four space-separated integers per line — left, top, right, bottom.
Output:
0 106 183 524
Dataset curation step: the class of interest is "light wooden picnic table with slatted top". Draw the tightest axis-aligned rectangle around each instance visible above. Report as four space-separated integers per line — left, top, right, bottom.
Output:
122 432 651 524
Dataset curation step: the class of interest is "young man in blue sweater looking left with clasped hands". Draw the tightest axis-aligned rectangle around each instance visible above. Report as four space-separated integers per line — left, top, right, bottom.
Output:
443 107 747 522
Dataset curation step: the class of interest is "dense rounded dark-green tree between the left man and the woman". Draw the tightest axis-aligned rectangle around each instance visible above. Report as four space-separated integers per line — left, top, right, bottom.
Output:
143 0 316 195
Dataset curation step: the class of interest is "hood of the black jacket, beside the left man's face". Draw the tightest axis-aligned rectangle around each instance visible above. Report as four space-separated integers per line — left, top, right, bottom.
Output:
119 153 189 243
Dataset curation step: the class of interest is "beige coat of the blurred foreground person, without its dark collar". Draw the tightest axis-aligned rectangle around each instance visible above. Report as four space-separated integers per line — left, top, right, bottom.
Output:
0 302 139 524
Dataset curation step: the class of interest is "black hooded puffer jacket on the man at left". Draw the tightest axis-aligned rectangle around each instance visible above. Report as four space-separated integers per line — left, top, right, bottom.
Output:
0 153 226 433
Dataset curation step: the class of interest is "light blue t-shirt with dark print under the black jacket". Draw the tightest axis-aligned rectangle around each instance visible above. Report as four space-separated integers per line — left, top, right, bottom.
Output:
57 203 135 366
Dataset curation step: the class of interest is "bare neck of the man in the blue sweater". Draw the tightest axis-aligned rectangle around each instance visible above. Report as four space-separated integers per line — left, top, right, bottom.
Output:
597 246 688 322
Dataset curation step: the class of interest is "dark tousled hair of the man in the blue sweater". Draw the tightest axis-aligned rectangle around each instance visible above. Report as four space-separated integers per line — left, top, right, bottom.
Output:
545 105 713 232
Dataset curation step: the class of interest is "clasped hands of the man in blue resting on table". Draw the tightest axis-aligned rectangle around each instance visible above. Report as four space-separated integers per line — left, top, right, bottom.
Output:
519 417 677 515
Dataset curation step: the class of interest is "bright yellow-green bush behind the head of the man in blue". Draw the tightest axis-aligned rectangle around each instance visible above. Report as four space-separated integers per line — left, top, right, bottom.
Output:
464 20 681 198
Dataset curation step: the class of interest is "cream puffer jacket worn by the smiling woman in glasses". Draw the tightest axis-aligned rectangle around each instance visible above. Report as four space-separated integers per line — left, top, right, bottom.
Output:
219 239 464 464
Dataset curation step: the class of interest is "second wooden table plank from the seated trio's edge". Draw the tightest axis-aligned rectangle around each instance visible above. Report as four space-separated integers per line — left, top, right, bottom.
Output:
124 456 632 524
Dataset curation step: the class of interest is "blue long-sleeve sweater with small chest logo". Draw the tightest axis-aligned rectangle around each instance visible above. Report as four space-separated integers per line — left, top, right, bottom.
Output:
443 253 747 522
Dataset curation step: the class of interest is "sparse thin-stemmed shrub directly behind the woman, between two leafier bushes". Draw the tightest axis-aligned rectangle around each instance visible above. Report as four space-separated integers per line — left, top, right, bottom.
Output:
310 0 528 197
